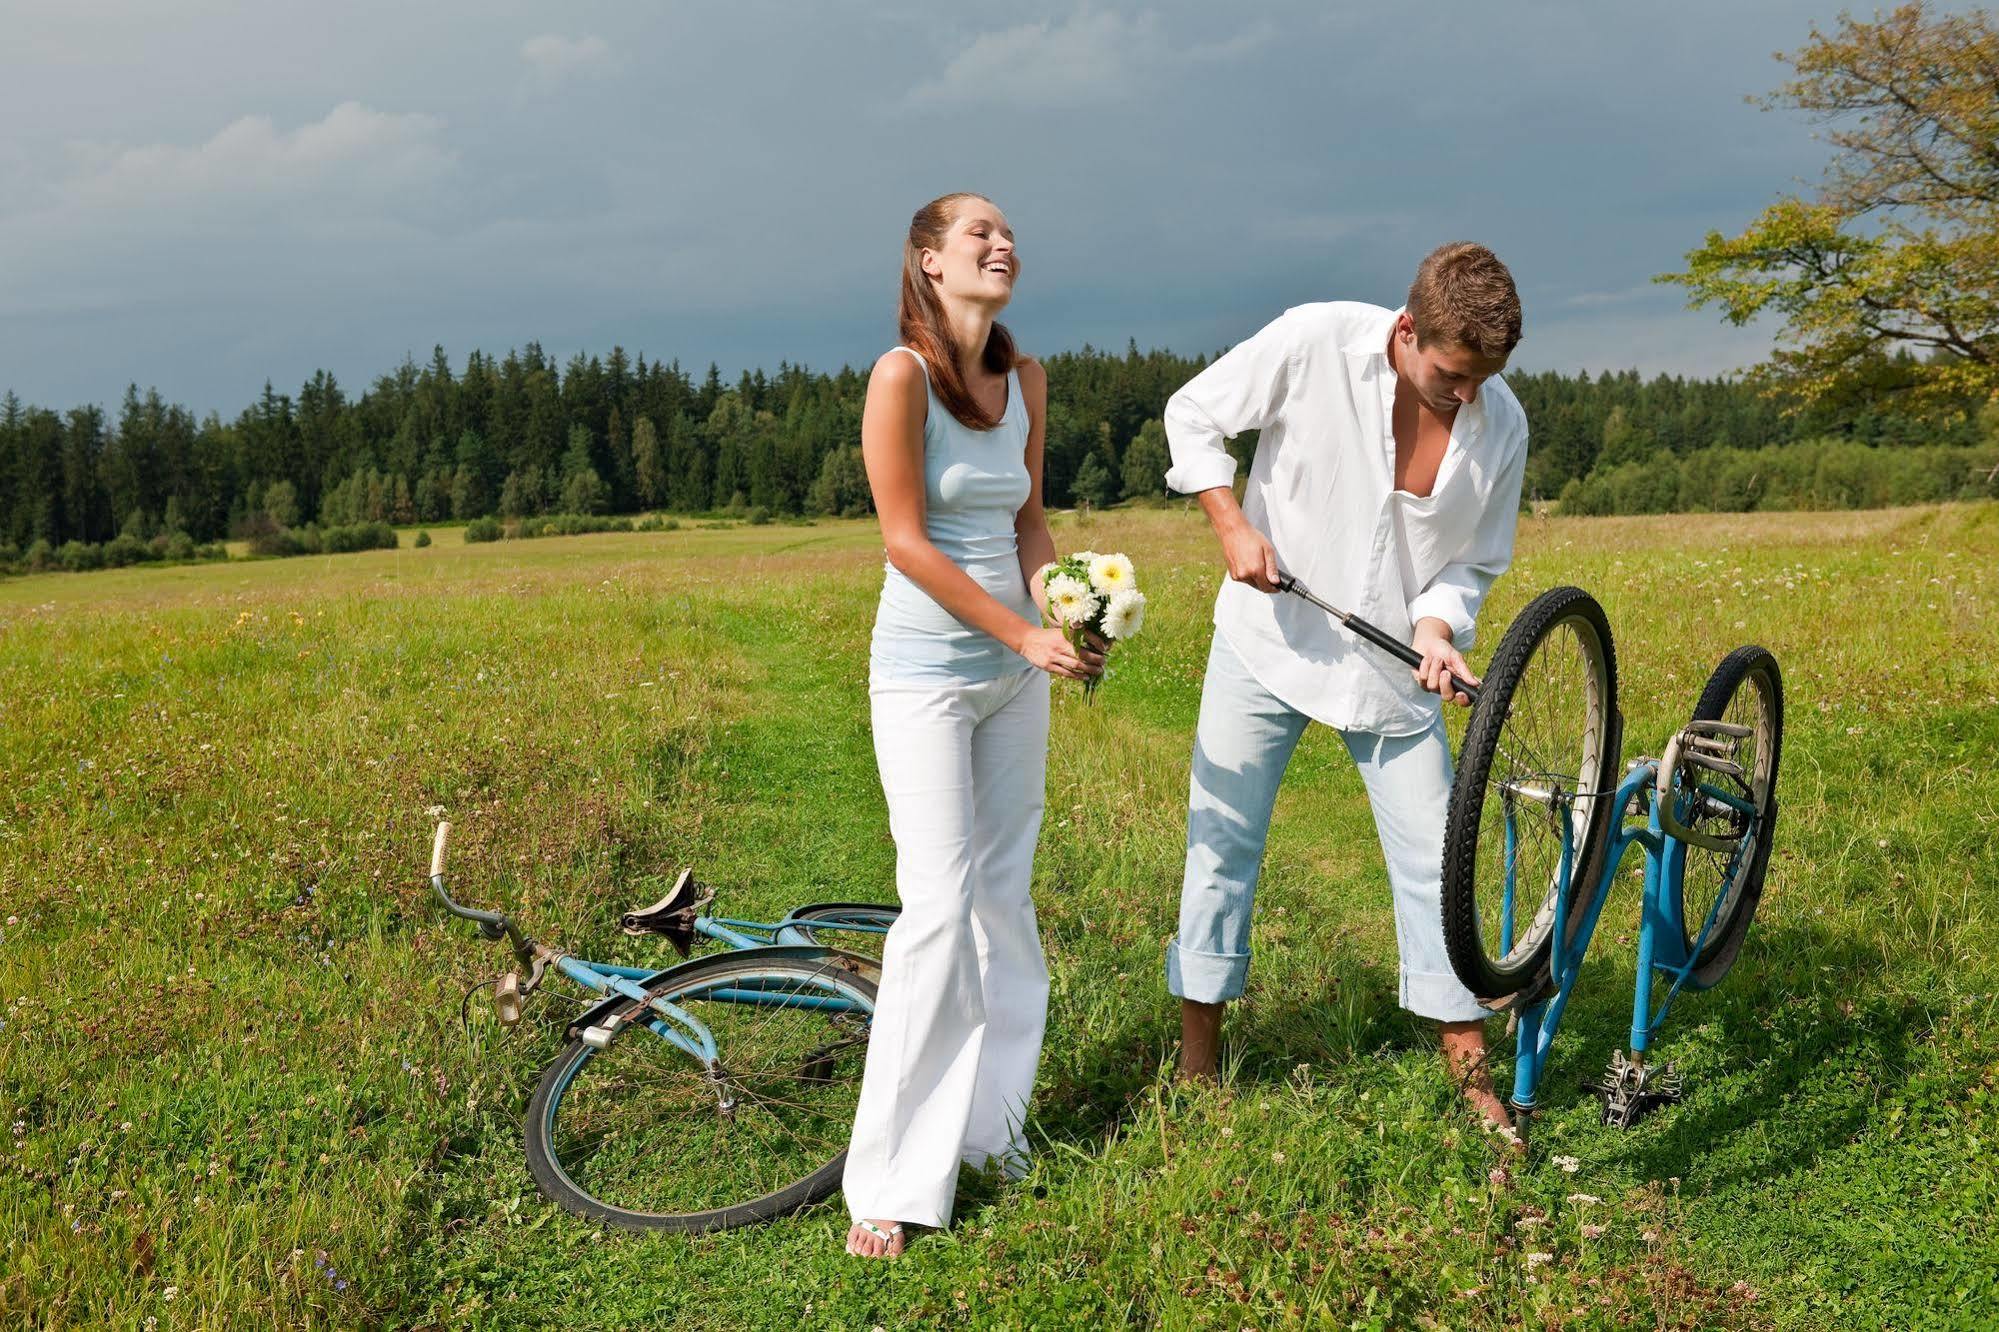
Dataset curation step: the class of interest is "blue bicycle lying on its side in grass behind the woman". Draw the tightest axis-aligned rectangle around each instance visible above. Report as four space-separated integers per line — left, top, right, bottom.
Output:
430 824 896 1230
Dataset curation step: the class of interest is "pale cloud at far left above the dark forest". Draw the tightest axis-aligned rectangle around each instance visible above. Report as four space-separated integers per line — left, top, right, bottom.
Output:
50 102 454 212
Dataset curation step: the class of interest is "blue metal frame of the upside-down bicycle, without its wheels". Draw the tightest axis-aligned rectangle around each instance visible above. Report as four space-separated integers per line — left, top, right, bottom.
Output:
1503 758 1761 1110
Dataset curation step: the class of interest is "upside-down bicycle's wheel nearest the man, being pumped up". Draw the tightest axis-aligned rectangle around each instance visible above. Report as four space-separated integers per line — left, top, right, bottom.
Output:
1443 588 1617 1000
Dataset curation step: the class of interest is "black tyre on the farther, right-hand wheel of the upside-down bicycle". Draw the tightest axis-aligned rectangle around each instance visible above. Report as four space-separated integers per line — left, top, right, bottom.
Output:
1677 644 1783 990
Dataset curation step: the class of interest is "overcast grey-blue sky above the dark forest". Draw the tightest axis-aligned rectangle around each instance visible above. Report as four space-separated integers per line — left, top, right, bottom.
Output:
0 0 1837 414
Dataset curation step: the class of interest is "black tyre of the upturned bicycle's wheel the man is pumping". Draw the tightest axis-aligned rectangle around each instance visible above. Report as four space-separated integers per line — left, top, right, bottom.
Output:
1441 588 1619 1004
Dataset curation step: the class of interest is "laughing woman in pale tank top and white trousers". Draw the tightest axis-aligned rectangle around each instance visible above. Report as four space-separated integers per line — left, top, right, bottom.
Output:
846 194 1103 1258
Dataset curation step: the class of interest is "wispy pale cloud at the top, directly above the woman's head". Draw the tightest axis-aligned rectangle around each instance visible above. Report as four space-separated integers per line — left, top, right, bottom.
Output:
908 8 1271 108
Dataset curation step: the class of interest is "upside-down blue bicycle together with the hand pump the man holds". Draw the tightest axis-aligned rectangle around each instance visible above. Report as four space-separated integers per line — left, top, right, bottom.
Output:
1279 578 1783 1128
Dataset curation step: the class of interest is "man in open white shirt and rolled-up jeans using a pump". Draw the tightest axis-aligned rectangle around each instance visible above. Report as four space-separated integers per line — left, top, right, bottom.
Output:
1165 242 1527 1142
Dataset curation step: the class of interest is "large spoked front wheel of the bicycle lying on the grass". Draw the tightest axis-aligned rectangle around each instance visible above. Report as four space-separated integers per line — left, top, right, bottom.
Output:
528 948 876 1230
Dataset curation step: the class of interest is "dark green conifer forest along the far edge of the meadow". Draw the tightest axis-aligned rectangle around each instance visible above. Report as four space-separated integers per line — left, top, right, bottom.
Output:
15 334 1979 558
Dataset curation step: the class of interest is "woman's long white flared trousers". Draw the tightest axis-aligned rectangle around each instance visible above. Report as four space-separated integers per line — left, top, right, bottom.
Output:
844 668 1049 1226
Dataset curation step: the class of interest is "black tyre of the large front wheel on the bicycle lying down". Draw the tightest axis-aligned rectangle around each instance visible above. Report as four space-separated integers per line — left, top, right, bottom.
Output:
526 946 876 1232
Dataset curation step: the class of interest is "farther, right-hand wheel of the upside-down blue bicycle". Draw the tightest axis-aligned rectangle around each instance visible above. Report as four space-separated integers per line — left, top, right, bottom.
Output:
1679 646 1783 990
